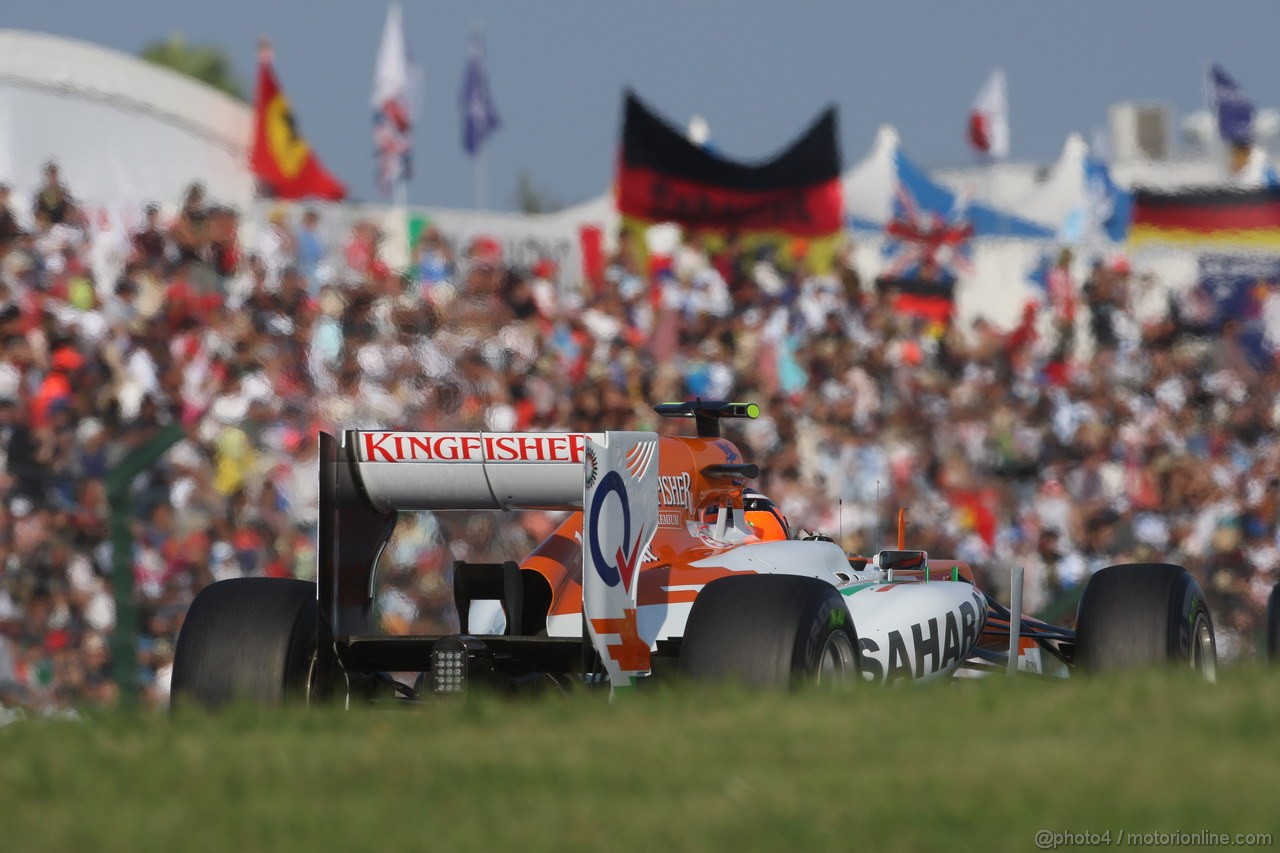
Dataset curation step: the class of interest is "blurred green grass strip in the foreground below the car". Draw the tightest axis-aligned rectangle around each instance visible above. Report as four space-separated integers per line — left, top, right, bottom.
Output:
0 670 1280 852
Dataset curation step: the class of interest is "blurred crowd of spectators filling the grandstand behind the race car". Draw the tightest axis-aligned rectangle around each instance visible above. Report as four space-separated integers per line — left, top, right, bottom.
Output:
0 165 1280 708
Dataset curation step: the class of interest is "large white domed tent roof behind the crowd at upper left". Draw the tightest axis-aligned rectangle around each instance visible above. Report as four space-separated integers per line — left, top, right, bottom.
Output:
0 29 253 216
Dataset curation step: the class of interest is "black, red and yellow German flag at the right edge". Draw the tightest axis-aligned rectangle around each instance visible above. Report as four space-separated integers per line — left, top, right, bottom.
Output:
1129 187 1280 250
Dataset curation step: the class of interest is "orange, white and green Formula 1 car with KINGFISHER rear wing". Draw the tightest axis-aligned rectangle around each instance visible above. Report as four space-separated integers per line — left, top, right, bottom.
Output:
173 401 1216 704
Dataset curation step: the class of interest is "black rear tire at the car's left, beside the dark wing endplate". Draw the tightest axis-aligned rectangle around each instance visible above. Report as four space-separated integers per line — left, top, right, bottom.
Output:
170 578 329 707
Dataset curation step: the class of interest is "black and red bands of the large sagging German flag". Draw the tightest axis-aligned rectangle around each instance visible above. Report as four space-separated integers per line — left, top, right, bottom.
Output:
616 91 844 238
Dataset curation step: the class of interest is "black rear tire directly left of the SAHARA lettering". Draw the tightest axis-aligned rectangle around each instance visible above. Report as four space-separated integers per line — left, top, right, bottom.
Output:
680 575 859 689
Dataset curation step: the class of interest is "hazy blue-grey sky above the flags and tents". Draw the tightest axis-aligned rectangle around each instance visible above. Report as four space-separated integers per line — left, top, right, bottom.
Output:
0 0 1280 209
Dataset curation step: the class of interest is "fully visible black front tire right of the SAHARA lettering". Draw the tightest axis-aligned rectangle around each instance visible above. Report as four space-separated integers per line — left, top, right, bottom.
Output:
1075 564 1217 681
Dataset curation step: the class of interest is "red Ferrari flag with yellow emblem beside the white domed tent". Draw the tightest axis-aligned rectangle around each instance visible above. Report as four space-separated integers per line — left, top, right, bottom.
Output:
250 42 347 201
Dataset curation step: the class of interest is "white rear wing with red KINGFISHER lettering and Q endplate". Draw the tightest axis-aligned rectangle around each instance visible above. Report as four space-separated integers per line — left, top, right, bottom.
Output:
316 430 658 684
